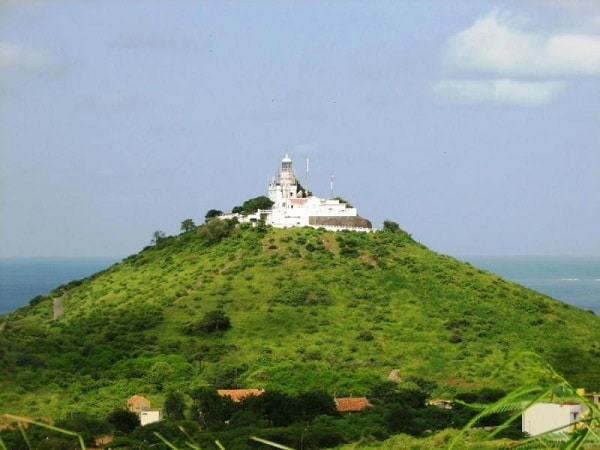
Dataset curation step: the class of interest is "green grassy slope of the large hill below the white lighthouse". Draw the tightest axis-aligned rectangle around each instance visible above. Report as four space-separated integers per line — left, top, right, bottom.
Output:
0 222 600 417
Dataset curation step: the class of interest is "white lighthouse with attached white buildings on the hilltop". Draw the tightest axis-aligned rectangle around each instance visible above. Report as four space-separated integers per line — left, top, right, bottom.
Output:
221 153 373 232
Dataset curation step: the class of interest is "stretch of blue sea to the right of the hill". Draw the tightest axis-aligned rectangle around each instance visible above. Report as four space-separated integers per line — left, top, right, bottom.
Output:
459 256 600 315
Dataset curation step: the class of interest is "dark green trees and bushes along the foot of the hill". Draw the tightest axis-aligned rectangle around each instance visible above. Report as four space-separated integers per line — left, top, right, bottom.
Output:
0 381 521 450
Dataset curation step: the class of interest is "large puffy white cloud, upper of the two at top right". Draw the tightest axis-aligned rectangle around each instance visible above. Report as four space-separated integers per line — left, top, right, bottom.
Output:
443 10 600 77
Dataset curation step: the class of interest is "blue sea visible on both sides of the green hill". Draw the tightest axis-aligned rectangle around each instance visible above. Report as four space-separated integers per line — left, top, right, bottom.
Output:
0 256 600 315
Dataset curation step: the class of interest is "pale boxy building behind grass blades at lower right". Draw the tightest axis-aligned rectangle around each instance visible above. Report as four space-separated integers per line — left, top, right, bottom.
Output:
521 402 587 436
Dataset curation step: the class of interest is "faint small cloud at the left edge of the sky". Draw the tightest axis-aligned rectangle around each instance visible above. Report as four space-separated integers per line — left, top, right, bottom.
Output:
0 42 62 73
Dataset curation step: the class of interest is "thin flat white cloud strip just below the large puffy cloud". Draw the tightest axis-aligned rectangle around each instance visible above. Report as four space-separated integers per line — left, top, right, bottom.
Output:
433 79 566 107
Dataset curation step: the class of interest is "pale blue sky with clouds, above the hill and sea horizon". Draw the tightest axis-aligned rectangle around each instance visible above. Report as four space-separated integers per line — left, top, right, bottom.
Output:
0 0 600 257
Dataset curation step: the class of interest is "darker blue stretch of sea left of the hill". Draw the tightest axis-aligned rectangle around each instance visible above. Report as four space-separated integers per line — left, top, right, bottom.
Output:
0 258 118 314
